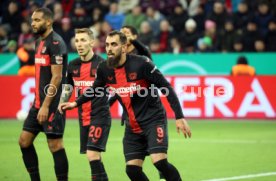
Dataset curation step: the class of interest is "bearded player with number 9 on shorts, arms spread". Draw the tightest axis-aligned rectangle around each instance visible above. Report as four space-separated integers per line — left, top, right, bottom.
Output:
60 31 191 181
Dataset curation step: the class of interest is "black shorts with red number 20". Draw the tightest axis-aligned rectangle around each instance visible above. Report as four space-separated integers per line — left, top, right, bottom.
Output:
80 119 111 154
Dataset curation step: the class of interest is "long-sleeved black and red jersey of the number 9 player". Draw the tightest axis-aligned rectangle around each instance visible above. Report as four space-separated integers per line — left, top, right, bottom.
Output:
76 55 184 133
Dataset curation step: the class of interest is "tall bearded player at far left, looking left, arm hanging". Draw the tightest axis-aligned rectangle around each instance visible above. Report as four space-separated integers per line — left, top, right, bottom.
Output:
19 8 68 181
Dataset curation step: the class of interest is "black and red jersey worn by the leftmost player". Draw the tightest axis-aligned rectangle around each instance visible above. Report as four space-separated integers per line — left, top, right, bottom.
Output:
34 31 67 109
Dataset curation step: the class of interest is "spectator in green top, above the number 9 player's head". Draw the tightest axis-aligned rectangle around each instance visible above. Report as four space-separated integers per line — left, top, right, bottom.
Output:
124 5 146 30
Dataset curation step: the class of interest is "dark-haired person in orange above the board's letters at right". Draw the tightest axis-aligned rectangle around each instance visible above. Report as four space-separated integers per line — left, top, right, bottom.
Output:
231 56 256 76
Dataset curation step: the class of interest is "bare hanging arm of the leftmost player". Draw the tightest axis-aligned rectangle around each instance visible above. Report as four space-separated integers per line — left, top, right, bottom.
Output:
37 65 63 124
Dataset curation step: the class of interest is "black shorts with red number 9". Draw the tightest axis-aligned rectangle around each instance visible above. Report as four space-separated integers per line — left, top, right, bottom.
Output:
123 124 168 161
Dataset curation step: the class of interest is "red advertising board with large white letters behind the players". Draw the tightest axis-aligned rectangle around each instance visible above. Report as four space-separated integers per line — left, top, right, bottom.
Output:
0 76 276 119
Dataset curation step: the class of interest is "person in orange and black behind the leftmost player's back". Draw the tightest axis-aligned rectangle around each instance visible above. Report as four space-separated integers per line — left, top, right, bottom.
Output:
16 38 35 76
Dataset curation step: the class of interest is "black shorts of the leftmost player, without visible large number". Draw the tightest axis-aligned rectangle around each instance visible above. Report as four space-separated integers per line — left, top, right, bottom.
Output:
23 107 65 139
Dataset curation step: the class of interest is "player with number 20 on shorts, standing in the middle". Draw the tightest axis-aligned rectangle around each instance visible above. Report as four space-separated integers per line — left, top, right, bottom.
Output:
60 28 111 181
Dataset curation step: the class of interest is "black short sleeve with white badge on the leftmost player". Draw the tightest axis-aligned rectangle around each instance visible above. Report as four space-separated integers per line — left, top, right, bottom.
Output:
49 40 67 65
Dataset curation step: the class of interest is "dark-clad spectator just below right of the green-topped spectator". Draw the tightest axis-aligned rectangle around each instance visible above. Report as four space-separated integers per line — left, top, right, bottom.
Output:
138 21 154 47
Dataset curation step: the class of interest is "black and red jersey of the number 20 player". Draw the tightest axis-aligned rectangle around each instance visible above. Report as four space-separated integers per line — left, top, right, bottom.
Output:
66 54 110 126
